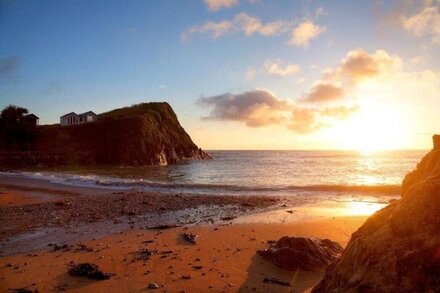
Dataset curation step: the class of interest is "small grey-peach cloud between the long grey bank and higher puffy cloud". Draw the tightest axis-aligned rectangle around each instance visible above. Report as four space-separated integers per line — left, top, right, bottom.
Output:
300 81 344 103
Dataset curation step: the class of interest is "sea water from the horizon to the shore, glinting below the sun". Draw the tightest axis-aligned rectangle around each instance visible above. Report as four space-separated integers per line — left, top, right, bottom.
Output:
9 151 426 198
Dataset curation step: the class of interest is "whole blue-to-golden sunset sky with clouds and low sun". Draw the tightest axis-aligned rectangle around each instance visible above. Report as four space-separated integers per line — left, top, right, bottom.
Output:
0 0 440 151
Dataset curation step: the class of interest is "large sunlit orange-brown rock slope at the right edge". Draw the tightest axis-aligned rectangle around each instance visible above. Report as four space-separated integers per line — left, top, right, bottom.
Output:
313 135 440 292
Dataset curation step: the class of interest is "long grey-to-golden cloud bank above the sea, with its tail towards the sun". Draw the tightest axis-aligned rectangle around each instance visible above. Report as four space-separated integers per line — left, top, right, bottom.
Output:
197 89 358 134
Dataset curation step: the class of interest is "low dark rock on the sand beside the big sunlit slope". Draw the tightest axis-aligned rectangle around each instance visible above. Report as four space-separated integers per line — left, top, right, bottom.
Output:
258 236 343 271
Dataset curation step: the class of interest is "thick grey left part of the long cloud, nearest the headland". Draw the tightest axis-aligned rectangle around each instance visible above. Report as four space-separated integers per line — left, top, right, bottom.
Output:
198 89 292 127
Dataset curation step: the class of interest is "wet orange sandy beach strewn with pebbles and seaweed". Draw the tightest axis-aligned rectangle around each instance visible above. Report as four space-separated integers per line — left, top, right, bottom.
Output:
0 174 374 292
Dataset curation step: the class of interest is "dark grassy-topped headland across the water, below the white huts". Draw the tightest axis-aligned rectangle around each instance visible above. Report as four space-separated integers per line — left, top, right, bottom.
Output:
31 103 210 165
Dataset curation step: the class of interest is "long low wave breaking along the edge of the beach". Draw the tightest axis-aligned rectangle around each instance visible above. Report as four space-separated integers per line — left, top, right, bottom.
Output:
0 172 401 195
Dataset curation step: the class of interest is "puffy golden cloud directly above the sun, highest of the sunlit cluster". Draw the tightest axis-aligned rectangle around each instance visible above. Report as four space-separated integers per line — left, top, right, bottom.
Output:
323 48 403 83
